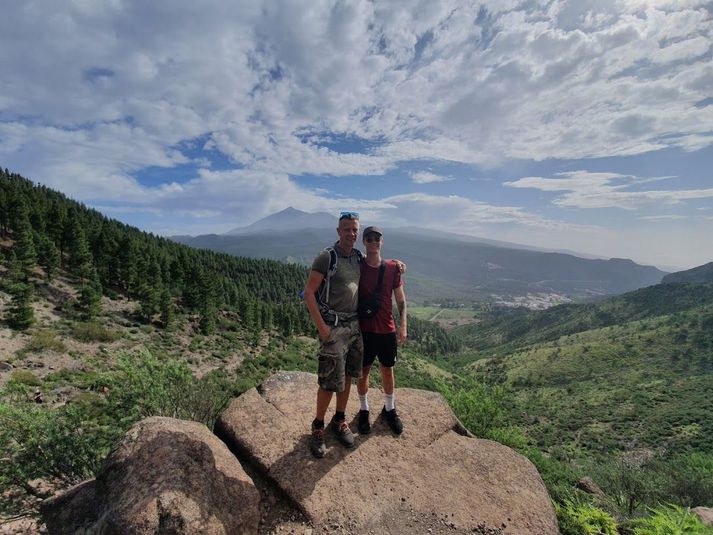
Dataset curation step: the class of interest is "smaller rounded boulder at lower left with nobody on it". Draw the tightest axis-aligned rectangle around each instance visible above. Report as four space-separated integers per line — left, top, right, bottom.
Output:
41 417 260 535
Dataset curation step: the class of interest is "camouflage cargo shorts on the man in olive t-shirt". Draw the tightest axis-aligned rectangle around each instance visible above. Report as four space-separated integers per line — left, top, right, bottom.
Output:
317 318 364 392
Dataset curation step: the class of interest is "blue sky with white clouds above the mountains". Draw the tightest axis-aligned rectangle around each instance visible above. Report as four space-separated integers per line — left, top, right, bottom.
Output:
0 0 713 268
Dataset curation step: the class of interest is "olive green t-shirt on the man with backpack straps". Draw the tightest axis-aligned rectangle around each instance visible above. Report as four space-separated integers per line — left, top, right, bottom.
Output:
312 242 361 313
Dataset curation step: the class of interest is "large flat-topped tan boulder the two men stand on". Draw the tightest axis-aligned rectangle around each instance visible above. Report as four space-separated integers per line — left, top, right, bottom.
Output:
216 372 559 535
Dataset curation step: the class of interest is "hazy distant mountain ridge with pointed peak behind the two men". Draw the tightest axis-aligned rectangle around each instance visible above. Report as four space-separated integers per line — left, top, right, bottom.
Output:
173 208 666 303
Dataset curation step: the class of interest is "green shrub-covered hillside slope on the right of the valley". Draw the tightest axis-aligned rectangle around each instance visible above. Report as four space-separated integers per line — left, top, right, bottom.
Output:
452 284 713 455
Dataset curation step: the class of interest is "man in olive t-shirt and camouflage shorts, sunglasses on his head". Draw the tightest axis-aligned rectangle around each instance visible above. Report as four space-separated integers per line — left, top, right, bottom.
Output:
304 212 363 458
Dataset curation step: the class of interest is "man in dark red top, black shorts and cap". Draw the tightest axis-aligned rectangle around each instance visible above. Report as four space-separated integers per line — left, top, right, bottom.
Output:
357 226 407 435
